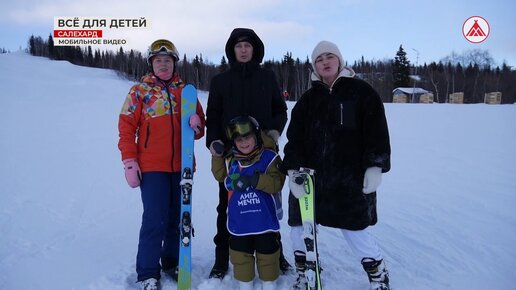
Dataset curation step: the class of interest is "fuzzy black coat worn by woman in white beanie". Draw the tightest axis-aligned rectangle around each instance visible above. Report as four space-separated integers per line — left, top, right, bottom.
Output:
282 77 391 230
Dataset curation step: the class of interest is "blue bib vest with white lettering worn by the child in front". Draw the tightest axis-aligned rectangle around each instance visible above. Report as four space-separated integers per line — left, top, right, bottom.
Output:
225 149 279 236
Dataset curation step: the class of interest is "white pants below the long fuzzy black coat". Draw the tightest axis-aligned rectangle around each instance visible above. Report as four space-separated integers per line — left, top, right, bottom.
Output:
290 226 383 262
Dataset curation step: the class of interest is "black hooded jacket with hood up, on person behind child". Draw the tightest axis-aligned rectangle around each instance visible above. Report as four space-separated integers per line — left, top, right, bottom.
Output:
206 28 287 148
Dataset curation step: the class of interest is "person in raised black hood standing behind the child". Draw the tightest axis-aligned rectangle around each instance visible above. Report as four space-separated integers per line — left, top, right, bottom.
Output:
206 28 291 278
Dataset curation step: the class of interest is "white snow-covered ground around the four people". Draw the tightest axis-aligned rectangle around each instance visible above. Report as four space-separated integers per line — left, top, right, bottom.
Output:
0 53 516 290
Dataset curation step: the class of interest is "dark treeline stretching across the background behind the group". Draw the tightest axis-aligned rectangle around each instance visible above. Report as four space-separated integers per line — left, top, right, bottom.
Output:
29 35 516 104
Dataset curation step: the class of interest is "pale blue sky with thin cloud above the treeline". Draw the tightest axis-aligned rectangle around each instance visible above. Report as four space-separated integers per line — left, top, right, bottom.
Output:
0 0 516 66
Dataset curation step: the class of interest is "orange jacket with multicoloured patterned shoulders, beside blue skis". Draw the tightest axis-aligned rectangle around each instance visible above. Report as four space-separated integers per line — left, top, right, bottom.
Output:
118 73 205 172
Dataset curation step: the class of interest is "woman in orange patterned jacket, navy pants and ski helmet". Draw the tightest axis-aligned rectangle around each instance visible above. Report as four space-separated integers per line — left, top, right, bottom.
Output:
118 39 205 289
